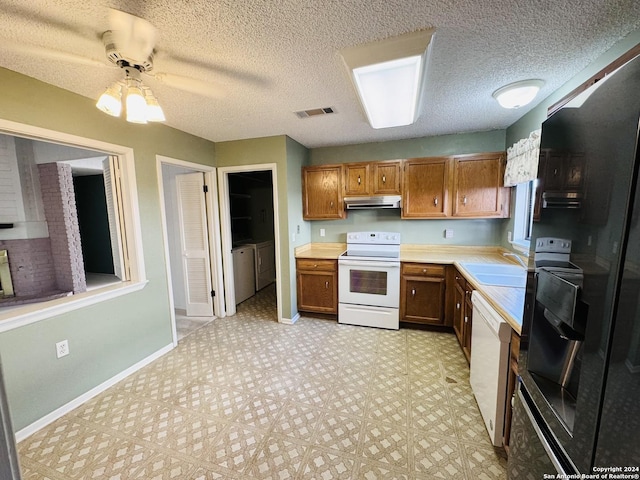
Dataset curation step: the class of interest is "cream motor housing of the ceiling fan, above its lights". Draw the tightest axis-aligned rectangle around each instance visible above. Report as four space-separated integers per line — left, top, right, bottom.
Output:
109 8 158 64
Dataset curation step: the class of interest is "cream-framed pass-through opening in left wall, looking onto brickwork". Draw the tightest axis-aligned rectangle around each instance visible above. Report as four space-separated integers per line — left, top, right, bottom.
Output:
0 120 146 331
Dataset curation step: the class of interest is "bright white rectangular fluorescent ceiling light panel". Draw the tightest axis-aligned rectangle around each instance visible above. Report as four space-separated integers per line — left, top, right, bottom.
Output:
353 56 422 128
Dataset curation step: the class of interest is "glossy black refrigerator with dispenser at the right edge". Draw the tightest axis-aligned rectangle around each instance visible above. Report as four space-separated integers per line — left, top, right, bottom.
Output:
508 53 640 480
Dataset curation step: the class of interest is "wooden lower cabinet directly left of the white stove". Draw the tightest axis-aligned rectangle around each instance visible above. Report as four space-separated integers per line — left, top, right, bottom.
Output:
296 258 338 314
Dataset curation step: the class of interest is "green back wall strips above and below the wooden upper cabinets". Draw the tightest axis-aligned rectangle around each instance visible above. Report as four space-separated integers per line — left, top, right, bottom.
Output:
308 130 506 245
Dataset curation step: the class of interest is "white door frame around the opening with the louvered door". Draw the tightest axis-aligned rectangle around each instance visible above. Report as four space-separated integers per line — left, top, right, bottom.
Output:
156 155 226 346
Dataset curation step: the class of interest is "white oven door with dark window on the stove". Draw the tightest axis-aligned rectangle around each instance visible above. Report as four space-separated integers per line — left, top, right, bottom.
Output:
338 260 400 308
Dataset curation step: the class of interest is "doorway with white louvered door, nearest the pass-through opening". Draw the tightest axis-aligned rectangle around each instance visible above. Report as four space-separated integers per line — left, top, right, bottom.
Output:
157 156 225 345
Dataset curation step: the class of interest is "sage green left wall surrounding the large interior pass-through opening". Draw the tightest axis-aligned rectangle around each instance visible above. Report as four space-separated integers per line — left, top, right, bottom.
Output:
0 68 215 430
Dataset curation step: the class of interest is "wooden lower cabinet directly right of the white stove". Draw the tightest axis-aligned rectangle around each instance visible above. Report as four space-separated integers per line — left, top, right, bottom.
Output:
400 263 446 325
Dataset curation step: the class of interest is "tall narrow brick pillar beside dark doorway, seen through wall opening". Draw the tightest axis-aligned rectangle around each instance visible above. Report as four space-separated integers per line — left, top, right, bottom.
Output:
38 163 87 293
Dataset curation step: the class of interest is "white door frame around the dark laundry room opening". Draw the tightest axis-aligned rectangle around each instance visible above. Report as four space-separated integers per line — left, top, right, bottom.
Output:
218 163 283 323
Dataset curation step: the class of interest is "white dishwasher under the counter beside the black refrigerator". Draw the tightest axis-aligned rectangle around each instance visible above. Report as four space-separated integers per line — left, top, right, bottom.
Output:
469 291 511 447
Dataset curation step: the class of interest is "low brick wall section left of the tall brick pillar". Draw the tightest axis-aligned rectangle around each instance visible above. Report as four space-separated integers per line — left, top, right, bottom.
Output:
0 238 57 297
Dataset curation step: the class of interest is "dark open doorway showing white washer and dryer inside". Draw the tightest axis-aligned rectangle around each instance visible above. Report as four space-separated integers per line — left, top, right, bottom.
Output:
218 164 282 321
